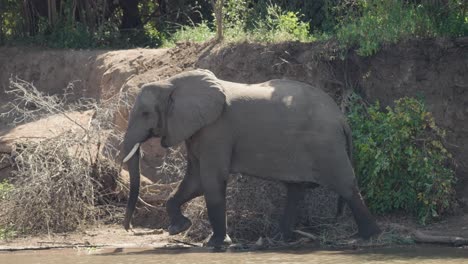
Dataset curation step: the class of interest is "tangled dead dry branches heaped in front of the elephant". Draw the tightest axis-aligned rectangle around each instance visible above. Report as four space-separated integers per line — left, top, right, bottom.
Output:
0 79 121 233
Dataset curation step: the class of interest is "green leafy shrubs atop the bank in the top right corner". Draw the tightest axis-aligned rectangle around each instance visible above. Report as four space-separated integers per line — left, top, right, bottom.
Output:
335 0 468 56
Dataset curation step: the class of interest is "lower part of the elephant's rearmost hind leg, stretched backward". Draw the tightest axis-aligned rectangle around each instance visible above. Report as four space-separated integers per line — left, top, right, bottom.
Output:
343 186 382 239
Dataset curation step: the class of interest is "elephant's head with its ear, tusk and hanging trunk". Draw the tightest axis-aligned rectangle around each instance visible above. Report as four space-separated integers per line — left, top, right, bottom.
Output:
123 70 226 230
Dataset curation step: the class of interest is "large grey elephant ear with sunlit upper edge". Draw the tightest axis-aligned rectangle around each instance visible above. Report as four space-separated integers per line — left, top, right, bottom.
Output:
164 70 226 147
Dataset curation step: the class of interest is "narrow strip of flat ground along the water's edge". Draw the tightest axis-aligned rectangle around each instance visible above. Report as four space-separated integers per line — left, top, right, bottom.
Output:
0 214 468 252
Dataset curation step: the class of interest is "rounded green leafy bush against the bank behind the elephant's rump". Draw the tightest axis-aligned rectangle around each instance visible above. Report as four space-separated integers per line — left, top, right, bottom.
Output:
348 96 455 223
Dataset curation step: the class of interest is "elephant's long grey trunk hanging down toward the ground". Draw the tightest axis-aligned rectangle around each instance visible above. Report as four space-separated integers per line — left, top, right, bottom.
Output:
124 140 140 231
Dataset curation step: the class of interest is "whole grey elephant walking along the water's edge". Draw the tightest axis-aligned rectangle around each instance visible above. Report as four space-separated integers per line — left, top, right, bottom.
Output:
123 70 380 247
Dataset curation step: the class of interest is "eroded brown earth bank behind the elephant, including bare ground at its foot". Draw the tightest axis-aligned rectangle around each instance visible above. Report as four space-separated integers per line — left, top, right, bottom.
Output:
0 39 468 250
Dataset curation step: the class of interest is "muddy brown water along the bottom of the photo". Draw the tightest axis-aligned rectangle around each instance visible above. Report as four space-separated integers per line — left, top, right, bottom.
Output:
0 247 468 264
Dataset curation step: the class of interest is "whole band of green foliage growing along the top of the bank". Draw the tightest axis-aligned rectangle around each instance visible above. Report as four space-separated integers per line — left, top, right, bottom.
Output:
0 0 468 51
